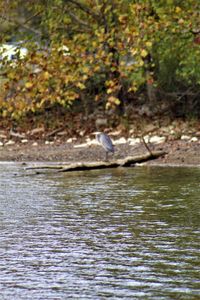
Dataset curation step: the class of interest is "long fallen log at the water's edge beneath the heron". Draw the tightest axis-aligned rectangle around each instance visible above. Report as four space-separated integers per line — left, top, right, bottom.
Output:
26 151 166 174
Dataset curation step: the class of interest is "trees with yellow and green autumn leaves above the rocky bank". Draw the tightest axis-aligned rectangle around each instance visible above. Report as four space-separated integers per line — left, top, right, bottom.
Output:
0 0 200 132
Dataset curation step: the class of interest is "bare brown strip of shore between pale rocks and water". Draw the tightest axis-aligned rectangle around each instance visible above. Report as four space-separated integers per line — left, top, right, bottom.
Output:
0 139 200 167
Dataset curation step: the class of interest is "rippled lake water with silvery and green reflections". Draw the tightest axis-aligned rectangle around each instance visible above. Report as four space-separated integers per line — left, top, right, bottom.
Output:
0 164 200 300
